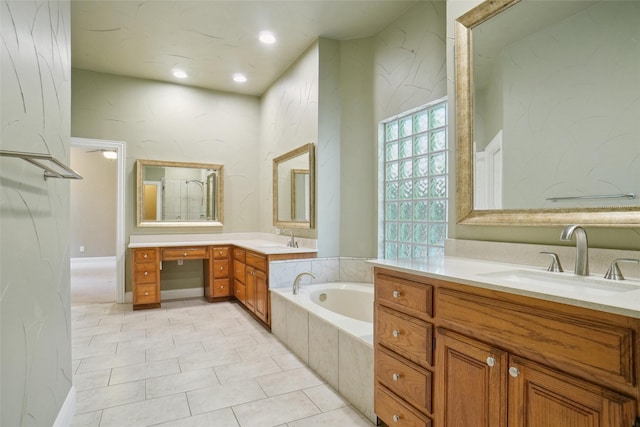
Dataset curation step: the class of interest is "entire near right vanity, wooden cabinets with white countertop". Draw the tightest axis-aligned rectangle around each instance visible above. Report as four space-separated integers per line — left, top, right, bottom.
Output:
373 257 640 427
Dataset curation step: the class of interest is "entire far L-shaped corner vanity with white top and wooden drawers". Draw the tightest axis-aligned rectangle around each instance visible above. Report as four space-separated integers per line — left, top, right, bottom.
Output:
129 235 317 326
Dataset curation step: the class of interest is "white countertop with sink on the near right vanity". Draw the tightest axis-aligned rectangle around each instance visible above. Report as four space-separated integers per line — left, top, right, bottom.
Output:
370 256 640 319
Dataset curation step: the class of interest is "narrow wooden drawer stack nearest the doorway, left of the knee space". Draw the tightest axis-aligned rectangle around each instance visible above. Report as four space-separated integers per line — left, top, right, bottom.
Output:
131 248 160 310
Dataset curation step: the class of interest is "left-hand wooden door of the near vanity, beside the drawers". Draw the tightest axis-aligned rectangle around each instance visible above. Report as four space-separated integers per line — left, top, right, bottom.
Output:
433 328 508 427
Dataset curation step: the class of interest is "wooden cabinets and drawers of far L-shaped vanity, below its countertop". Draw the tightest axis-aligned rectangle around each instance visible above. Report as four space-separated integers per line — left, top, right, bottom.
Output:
131 243 316 328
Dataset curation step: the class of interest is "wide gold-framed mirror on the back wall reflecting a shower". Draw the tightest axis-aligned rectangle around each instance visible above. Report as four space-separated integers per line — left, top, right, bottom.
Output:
136 160 224 227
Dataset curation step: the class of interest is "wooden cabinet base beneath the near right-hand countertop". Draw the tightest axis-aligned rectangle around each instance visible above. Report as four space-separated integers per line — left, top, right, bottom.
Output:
374 268 640 427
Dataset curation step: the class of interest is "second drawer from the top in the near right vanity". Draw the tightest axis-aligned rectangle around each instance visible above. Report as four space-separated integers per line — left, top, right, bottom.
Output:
375 306 433 366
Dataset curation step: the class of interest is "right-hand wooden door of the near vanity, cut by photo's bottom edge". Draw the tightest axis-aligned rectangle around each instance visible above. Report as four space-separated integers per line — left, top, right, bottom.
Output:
509 356 636 427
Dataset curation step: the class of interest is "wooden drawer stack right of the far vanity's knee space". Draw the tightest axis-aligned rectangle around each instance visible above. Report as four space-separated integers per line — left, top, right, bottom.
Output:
203 246 233 302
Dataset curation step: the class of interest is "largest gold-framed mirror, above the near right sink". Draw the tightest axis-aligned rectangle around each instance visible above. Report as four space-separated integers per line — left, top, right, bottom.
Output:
455 0 640 226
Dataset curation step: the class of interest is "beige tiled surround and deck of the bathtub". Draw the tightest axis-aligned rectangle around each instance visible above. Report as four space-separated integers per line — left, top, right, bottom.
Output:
270 282 376 422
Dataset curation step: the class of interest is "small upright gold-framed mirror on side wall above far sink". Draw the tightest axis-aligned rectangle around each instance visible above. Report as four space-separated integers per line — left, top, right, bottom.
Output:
273 144 316 228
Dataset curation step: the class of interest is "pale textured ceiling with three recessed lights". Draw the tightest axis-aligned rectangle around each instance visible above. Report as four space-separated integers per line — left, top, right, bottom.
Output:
71 0 420 95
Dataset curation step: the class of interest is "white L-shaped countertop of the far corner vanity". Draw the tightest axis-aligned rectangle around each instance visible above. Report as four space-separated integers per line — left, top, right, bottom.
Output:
129 233 318 255
